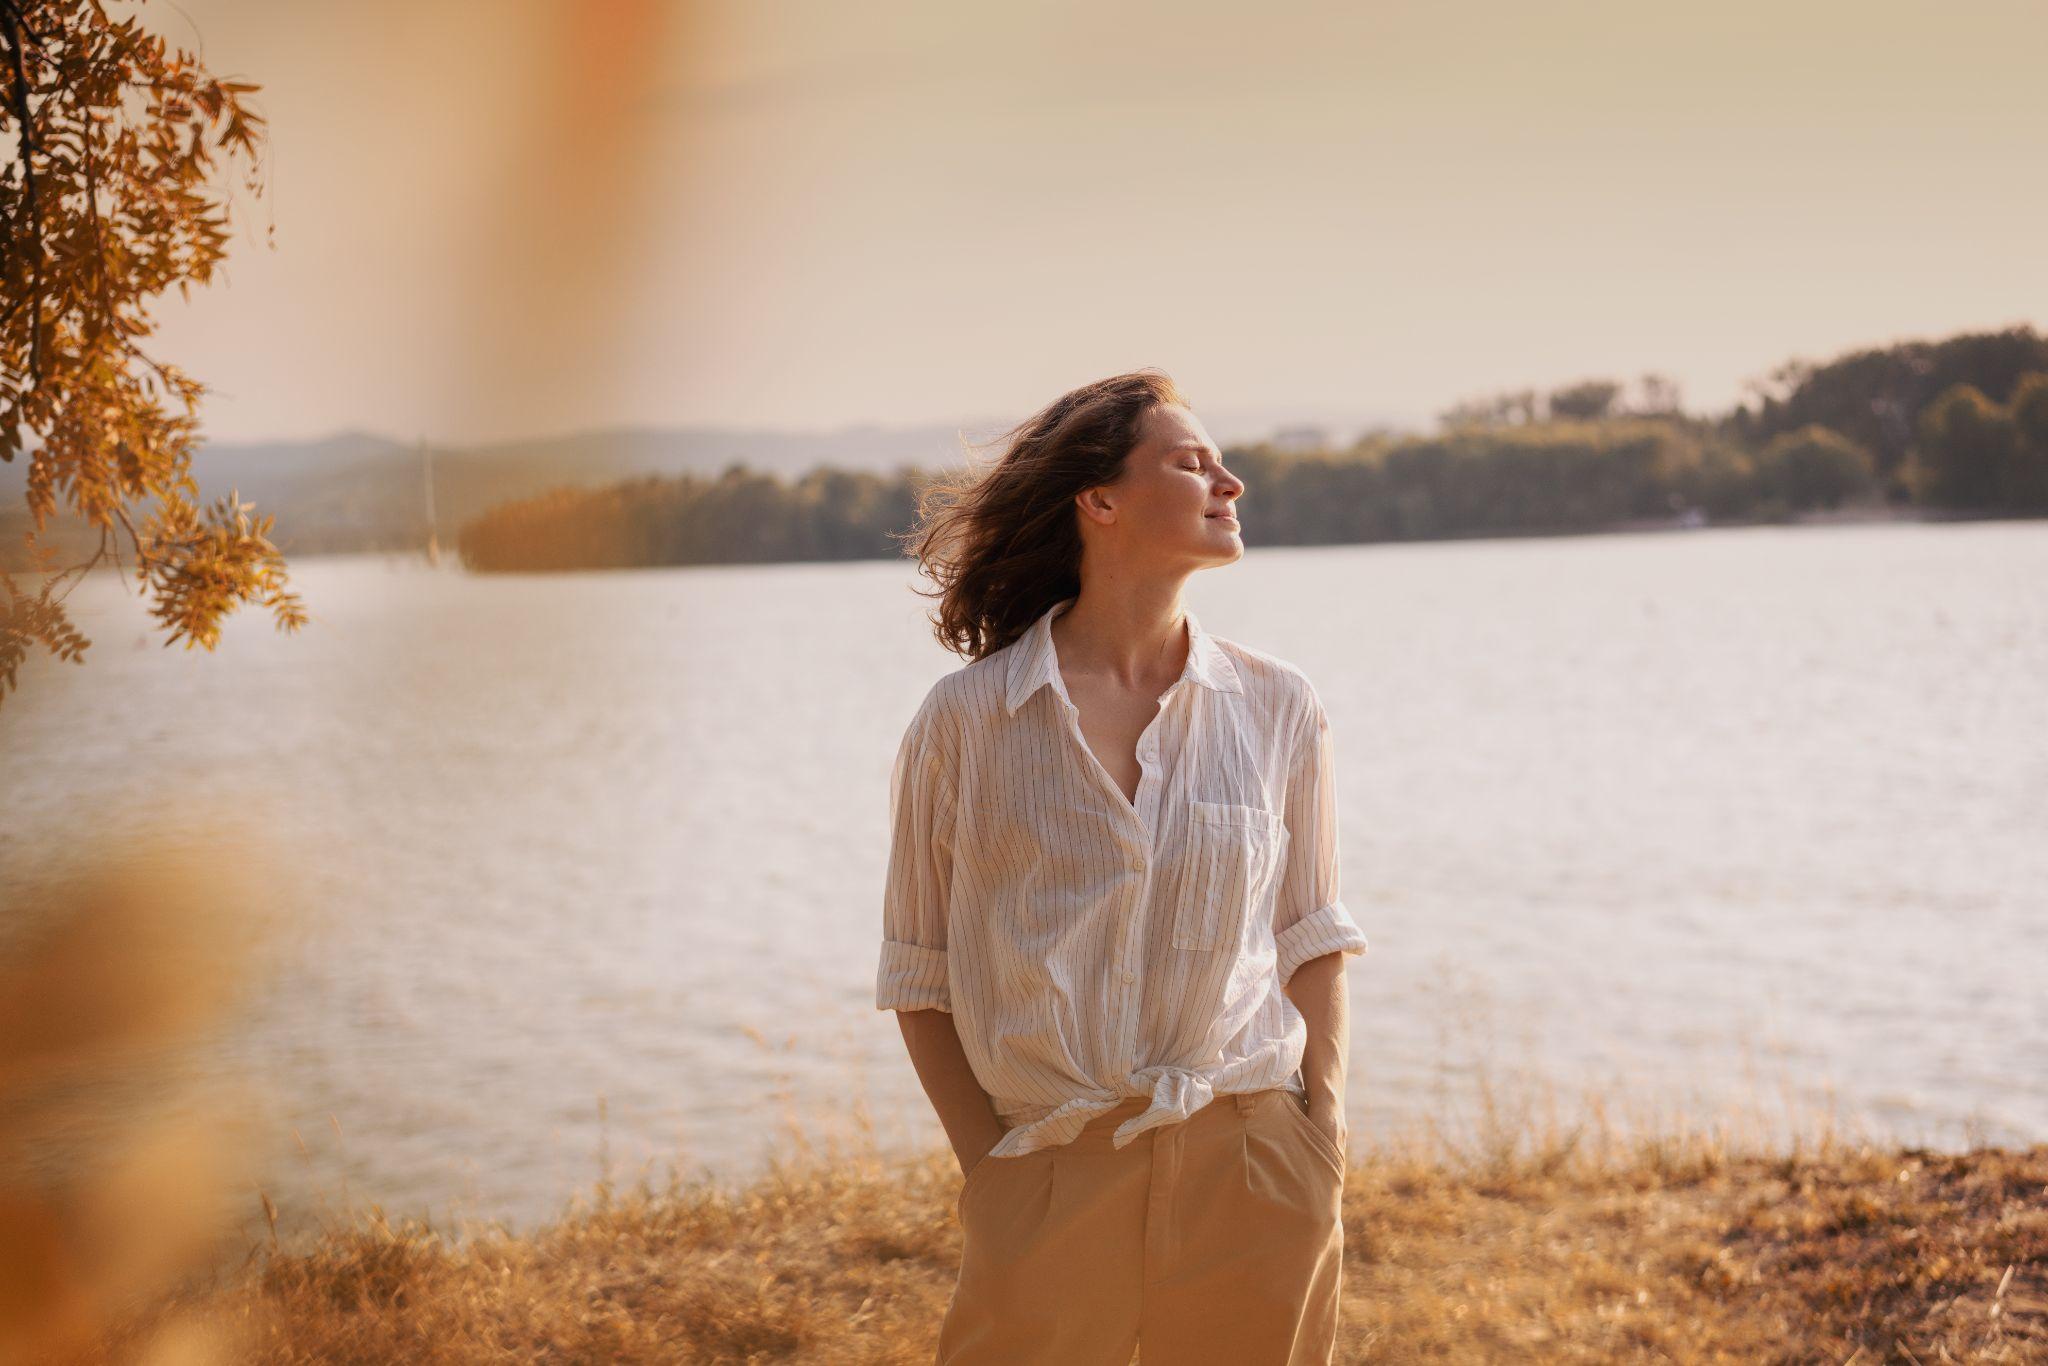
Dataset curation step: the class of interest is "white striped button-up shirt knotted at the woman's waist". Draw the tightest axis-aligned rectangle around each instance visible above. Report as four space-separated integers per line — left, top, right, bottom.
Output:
874 598 1366 1157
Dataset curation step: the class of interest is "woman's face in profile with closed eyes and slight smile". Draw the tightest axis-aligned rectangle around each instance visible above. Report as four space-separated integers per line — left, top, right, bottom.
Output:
1083 403 1245 565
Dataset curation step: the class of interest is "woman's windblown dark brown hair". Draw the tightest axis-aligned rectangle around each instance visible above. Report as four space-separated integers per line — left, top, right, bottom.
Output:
899 369 1188 659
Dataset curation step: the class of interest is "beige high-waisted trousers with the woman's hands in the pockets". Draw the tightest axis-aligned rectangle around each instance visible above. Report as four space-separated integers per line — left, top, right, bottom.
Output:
938 1087 1346 1366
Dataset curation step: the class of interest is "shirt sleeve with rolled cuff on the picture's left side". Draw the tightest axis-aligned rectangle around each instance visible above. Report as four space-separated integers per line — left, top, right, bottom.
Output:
874 705 954 1012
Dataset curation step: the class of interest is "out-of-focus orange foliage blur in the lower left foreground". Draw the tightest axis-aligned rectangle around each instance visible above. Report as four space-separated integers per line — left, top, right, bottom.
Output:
0 813 266 1366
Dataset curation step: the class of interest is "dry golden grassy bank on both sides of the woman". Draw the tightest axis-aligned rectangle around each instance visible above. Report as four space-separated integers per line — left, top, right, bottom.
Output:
108 1104 2048 1362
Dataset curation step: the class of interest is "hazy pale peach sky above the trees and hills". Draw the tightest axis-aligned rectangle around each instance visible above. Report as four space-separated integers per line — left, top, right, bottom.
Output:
144 0 2048 442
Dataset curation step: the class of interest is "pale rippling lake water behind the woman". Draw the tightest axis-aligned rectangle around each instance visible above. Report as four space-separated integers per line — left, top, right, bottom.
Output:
0 522 2048 1233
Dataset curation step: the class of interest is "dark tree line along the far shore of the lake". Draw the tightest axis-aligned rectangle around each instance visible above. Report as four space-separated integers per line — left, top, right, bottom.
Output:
459 328 2048 571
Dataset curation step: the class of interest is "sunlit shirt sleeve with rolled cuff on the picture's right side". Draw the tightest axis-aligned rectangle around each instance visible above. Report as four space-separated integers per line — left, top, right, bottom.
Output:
1274 688 1366 985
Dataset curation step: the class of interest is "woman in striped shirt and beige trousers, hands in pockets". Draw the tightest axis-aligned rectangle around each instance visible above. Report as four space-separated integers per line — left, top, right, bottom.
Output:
877 371 1366 1366
